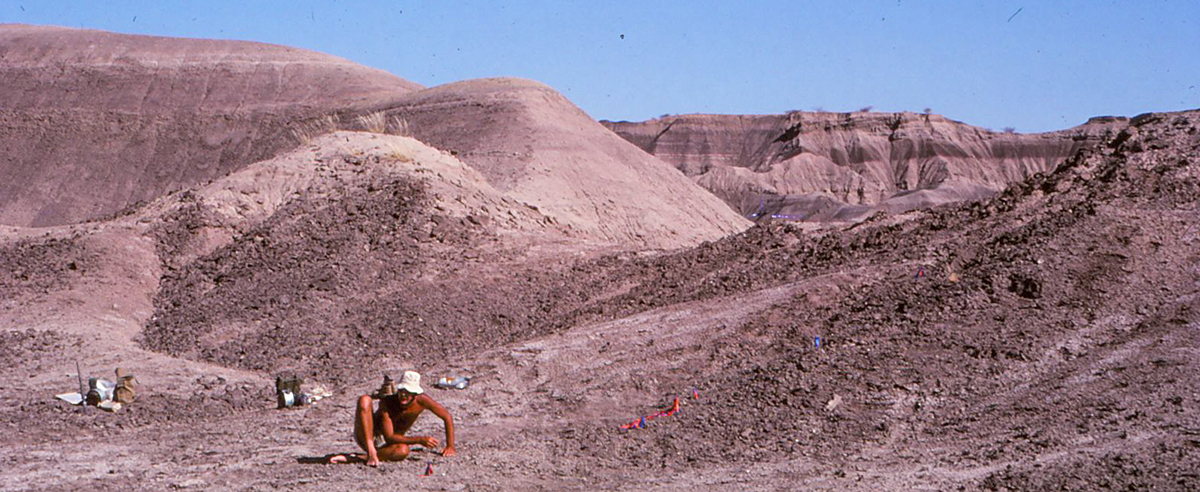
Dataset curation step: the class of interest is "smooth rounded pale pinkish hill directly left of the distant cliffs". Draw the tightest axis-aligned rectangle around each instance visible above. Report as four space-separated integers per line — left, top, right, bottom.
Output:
388 78 748 247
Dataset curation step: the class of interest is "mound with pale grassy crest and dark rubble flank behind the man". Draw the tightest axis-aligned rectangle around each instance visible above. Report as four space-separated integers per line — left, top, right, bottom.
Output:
139 133 633 383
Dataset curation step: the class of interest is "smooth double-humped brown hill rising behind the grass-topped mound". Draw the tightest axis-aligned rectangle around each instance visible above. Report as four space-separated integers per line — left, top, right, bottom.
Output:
0 25 749 247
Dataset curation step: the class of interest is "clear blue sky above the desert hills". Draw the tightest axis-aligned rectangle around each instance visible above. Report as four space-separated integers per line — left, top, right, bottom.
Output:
0 0 1200 132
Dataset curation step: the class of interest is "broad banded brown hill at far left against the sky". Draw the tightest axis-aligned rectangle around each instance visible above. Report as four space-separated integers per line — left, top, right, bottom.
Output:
0 24 420 226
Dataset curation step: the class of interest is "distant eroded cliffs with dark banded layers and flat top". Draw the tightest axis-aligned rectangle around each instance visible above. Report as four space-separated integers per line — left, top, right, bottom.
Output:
602 112 1124 221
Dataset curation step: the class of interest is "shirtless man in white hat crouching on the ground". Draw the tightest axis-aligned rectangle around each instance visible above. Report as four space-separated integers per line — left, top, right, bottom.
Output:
329 371 455 467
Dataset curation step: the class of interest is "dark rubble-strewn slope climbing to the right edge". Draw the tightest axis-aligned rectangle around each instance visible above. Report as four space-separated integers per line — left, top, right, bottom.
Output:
542 113 1200 491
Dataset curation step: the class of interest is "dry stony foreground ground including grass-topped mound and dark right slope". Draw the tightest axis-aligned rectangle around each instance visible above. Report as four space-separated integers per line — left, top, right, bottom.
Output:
0 113 1200 491
